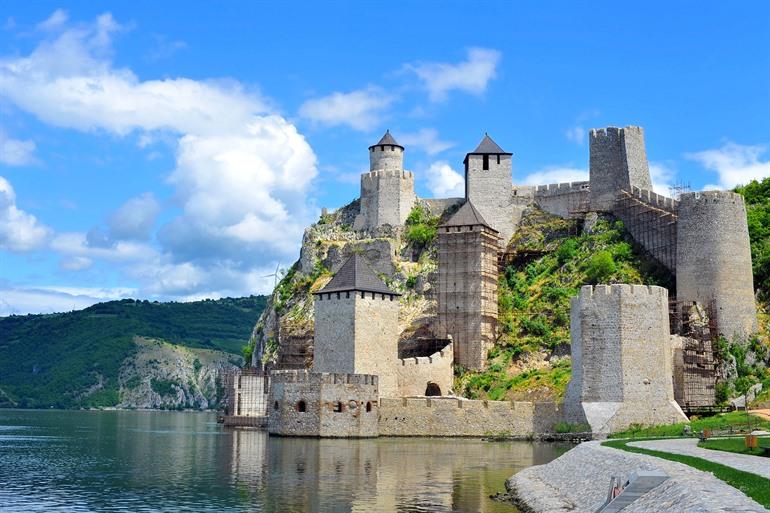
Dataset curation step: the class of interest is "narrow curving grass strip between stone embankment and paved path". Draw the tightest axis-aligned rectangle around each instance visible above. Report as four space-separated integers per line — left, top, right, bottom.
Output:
602 440 770 508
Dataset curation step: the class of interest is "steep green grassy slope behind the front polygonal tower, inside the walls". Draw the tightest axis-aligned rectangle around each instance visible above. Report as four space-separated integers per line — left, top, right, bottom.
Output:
455 211 671 400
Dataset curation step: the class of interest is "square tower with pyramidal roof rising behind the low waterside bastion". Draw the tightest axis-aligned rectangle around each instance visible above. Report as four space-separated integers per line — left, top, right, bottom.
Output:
313 253 400 397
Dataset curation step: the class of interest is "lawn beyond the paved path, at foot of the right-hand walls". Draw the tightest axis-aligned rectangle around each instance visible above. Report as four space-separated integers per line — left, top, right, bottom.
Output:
610 411 770 438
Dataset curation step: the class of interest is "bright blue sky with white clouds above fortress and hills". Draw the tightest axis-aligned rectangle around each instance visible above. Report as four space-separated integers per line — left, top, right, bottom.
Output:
0 1 770 316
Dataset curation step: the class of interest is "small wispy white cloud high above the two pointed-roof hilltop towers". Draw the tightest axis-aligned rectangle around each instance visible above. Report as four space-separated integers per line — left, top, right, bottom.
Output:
406 48 501 101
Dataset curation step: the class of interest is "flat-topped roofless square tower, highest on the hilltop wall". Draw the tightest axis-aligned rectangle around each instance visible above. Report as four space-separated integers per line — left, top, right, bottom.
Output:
589 126 652 211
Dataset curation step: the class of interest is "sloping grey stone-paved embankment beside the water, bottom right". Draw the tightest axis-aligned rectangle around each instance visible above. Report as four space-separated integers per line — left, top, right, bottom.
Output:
506 442 768 513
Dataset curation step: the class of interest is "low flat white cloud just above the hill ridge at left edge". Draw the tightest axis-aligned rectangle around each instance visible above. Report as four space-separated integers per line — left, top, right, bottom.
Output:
0 283 136 317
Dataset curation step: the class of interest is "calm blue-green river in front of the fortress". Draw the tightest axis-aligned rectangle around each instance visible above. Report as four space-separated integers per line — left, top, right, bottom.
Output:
0 410 568 512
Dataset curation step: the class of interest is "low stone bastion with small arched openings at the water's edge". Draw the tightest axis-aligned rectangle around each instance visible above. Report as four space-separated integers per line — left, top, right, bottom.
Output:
268 370 379 438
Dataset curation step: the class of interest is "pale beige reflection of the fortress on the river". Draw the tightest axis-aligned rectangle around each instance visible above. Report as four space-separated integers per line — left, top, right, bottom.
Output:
222 430 558 513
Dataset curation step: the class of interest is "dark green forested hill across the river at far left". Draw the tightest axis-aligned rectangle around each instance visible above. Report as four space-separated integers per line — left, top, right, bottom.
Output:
0 296 266 408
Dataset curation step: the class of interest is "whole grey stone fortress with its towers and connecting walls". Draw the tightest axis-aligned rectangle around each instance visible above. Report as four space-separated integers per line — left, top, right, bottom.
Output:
230 126 757 437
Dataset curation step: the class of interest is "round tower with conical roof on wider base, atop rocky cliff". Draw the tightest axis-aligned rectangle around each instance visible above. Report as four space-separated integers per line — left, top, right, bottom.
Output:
353 131 416 230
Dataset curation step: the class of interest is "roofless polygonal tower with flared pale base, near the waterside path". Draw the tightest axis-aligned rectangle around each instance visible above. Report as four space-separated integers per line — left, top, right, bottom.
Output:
564 285 687 433
